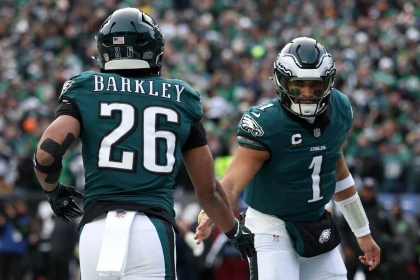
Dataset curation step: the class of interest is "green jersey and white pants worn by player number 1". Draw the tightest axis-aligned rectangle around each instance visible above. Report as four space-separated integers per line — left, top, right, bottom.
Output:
238 89 353 280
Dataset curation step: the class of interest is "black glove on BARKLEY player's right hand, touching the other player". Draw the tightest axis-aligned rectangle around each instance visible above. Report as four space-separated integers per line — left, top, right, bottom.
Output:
225 212 255 261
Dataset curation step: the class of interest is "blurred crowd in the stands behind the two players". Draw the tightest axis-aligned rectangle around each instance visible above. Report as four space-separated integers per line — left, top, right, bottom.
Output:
0 0 420 280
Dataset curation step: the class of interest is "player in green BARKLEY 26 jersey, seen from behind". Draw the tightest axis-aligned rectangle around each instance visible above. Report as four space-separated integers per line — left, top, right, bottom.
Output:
34 8 254 280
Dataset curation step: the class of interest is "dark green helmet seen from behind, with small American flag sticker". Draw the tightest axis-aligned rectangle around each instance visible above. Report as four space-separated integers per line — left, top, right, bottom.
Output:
95 8 165 74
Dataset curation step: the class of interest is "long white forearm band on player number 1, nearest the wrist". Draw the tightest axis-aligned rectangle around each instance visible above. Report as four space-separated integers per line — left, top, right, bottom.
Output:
335 193 370 237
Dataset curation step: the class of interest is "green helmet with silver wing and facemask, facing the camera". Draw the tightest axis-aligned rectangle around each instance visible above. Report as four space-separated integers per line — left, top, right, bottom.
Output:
274 37 336 117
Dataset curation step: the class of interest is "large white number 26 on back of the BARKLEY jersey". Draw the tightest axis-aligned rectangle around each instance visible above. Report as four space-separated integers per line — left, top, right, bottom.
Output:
98 103 179 173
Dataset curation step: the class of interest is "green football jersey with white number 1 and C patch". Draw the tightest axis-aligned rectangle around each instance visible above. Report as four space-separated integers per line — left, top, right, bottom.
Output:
238 89 353 221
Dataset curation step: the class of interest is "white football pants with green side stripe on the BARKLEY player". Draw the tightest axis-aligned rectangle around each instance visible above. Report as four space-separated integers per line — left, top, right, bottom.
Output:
79 213 177 280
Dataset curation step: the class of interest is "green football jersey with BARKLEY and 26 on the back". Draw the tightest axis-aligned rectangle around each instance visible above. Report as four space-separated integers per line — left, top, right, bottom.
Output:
60 72 203 214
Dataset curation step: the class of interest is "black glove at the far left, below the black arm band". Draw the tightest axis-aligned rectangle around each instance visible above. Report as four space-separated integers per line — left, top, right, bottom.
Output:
44 183 83 223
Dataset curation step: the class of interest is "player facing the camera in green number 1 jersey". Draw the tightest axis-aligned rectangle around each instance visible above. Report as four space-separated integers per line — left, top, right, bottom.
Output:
195 37 380 280
